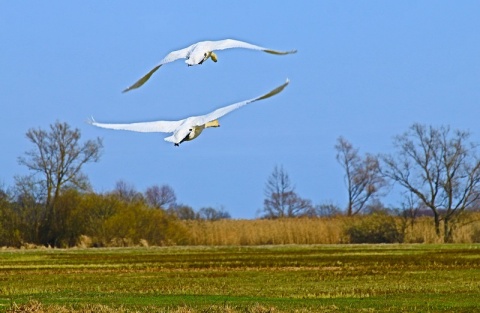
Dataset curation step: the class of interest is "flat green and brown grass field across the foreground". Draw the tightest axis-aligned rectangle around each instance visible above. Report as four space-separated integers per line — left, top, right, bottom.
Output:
0 244 480 312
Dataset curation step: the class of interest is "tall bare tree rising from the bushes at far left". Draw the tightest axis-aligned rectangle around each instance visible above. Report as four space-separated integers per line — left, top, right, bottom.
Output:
18 121 102 245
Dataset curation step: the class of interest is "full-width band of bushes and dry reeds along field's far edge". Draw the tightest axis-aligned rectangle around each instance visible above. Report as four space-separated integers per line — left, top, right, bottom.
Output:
0 183 480 247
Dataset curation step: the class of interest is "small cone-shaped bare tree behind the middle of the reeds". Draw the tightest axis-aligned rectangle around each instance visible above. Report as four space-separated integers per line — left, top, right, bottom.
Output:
263 166 314 218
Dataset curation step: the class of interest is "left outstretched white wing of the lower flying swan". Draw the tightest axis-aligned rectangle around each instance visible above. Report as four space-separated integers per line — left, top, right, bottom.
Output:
88 118 184 133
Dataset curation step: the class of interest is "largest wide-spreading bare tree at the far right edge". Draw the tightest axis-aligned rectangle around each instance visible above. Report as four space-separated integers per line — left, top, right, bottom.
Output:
382 124 480 242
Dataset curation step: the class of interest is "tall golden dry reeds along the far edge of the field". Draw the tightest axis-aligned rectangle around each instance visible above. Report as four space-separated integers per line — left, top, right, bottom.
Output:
180 213 480 245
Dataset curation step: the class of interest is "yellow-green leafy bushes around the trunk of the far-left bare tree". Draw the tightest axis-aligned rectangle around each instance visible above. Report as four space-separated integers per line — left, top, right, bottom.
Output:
0 190 191 247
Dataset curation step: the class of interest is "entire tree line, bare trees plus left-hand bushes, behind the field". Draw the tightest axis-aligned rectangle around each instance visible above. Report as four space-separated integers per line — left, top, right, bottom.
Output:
0 121 480 247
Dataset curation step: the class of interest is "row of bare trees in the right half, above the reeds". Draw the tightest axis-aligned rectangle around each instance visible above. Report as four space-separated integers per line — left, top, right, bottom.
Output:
264 124 480 242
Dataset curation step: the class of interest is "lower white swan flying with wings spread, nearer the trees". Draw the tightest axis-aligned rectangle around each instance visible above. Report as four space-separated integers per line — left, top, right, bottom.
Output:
92 79 289 146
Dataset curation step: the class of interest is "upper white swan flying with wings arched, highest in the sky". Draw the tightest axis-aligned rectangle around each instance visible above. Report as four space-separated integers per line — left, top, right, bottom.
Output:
123 39 297 92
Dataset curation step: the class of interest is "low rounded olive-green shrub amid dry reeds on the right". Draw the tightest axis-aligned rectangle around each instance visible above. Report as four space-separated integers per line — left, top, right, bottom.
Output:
345 214 403 243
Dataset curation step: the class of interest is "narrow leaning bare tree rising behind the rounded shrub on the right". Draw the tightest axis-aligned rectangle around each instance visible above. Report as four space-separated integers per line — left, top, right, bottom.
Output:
335 137 386 216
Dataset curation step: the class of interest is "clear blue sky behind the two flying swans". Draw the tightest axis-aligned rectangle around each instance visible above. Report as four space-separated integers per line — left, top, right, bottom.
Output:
0 0 480 218
